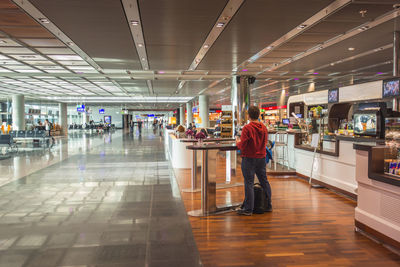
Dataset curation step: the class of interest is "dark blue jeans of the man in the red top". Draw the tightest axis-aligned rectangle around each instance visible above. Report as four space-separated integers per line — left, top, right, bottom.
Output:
242 158 272 212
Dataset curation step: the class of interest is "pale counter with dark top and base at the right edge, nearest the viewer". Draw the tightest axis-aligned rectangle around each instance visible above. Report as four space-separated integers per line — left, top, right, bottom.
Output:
354 143 400 249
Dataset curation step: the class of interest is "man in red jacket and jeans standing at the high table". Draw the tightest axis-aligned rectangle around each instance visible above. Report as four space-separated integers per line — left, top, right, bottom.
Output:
236 106 272 216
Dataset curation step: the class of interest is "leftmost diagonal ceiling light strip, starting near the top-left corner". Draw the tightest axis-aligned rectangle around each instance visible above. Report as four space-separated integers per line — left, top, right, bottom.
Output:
12 0 101 71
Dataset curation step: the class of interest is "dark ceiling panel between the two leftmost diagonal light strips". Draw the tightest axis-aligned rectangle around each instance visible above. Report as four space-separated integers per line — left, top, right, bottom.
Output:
31 0 141 69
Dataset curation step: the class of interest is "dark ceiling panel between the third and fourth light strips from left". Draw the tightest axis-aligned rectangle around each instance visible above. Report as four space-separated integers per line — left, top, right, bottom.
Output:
198 0 333 70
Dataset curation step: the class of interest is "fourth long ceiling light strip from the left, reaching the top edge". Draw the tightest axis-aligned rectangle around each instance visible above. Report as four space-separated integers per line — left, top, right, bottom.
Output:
237 0 352 73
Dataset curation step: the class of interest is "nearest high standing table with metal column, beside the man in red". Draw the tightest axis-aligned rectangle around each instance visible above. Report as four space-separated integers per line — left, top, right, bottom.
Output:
187 143 241 216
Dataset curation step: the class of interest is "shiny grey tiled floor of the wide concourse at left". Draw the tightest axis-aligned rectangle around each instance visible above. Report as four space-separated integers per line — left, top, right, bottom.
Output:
0 130 201 267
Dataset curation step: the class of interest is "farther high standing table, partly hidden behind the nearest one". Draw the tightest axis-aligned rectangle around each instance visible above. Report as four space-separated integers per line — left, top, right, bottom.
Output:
180 138 236 193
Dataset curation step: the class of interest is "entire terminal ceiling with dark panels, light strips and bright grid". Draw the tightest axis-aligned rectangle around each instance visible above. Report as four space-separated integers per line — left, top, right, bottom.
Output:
0 0 400 109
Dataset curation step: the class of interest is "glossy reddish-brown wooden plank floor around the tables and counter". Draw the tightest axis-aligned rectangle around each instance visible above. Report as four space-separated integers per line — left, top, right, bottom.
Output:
175 156 400 267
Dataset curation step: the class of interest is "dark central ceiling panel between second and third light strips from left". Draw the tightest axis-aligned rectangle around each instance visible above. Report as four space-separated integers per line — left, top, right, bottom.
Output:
139 0 228 70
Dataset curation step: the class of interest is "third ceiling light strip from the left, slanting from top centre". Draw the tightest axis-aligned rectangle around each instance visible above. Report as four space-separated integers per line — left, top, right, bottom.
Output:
175 0 245 93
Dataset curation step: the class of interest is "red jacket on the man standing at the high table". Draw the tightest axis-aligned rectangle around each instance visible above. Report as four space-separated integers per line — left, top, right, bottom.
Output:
237 122 268 158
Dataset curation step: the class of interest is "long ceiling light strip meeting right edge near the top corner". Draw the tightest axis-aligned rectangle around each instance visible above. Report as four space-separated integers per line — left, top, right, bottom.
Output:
258 10 400 75
